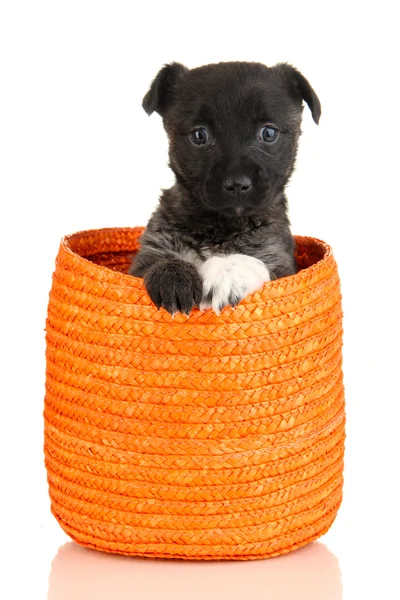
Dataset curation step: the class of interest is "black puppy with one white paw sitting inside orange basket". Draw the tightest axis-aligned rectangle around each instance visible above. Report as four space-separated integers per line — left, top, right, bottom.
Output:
130 62 321 314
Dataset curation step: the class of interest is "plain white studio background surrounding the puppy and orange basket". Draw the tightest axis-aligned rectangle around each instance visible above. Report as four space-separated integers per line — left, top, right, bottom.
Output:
0 0 400 600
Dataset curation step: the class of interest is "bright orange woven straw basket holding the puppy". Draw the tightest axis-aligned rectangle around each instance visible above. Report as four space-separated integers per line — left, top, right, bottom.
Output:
44 228 345 559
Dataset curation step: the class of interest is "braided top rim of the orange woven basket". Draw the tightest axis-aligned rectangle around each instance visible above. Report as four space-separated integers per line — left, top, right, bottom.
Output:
60 225 334 300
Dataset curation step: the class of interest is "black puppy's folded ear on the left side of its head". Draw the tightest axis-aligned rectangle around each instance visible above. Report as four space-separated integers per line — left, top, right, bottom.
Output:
142 62 189 117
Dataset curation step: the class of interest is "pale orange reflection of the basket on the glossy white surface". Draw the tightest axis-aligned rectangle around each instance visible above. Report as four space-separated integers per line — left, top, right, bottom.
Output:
48 542 342 600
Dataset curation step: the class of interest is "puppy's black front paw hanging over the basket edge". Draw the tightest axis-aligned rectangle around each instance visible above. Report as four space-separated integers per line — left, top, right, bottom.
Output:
144 260 203 315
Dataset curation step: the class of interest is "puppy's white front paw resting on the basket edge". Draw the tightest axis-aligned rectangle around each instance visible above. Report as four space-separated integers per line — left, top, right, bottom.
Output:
199 254 270 314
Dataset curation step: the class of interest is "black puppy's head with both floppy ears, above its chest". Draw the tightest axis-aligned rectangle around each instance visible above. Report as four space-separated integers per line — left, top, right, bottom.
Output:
143 62 321 215
